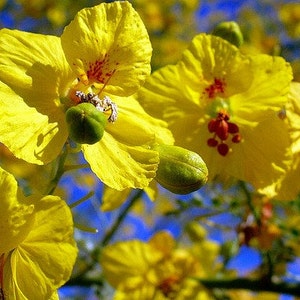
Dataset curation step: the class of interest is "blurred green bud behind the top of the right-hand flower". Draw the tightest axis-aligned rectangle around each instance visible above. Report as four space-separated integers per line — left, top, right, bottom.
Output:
212 21 244 47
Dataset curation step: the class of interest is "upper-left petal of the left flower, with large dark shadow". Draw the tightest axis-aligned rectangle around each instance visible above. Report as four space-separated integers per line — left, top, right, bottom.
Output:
0 29 76 95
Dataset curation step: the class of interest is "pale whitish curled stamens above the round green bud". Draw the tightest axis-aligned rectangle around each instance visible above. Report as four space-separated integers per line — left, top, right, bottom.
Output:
75 91 118 123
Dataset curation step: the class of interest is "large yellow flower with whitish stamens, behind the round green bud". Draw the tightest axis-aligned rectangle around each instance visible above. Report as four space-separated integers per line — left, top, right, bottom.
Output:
0 1 170 190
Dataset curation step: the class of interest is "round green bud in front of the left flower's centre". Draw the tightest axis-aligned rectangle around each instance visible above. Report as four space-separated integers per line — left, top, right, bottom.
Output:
66 103 107 144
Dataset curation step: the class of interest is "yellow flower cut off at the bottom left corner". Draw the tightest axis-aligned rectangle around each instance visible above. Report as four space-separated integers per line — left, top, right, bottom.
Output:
0 169 77 300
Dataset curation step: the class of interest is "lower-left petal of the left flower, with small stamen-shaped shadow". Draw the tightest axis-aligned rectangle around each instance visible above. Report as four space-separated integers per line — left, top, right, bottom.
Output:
0 82 68 164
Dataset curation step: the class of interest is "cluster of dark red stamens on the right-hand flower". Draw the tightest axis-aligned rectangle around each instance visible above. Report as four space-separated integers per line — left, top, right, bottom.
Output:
207 109 241 156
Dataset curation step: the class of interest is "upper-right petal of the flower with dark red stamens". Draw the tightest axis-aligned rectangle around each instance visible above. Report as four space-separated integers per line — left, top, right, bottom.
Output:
230 54 292 122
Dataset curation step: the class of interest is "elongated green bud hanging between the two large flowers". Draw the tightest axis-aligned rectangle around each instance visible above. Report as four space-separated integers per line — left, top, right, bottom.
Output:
155 145 208 194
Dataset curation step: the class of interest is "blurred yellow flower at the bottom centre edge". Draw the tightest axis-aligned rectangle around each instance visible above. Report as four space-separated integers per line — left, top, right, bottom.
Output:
101 232 208 300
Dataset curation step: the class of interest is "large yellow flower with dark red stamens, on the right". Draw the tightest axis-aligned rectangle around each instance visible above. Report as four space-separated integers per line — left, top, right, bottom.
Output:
138 34 292 187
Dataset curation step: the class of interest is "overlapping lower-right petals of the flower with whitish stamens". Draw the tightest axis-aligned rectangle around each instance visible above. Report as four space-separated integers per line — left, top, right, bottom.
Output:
82 97 173 190
